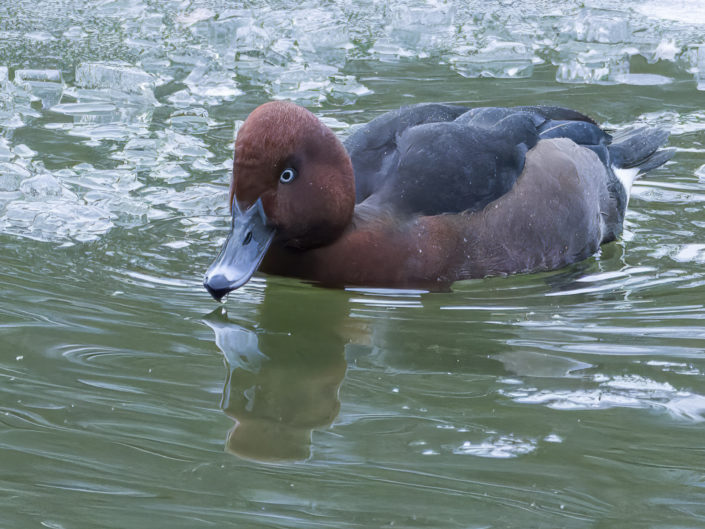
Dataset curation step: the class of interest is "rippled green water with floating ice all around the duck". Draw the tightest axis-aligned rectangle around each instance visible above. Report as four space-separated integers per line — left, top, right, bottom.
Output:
0 0 705 529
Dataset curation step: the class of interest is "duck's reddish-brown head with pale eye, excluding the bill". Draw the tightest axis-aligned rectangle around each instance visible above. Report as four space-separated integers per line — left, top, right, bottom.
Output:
230 101 355 248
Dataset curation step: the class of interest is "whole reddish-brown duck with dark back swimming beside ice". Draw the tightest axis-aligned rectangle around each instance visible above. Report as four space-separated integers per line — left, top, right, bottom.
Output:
203 101 674 300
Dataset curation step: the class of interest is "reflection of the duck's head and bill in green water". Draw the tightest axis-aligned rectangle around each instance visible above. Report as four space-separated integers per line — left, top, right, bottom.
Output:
205 288 347 461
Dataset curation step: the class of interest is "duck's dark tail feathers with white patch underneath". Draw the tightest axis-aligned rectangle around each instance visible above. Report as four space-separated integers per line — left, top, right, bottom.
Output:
607 127 676 193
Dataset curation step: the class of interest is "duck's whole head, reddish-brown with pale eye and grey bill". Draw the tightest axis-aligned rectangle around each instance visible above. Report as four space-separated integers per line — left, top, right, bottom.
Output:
203 101 355 300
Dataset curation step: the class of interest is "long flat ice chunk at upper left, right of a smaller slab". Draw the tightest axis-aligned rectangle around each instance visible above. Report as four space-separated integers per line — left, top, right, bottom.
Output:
76 61 156 94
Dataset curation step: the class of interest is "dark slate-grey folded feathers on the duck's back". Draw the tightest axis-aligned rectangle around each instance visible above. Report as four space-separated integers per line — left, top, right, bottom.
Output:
345 103 611 215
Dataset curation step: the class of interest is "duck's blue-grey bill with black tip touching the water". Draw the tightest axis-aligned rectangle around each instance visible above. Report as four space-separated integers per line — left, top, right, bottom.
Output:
203 200 274 301
